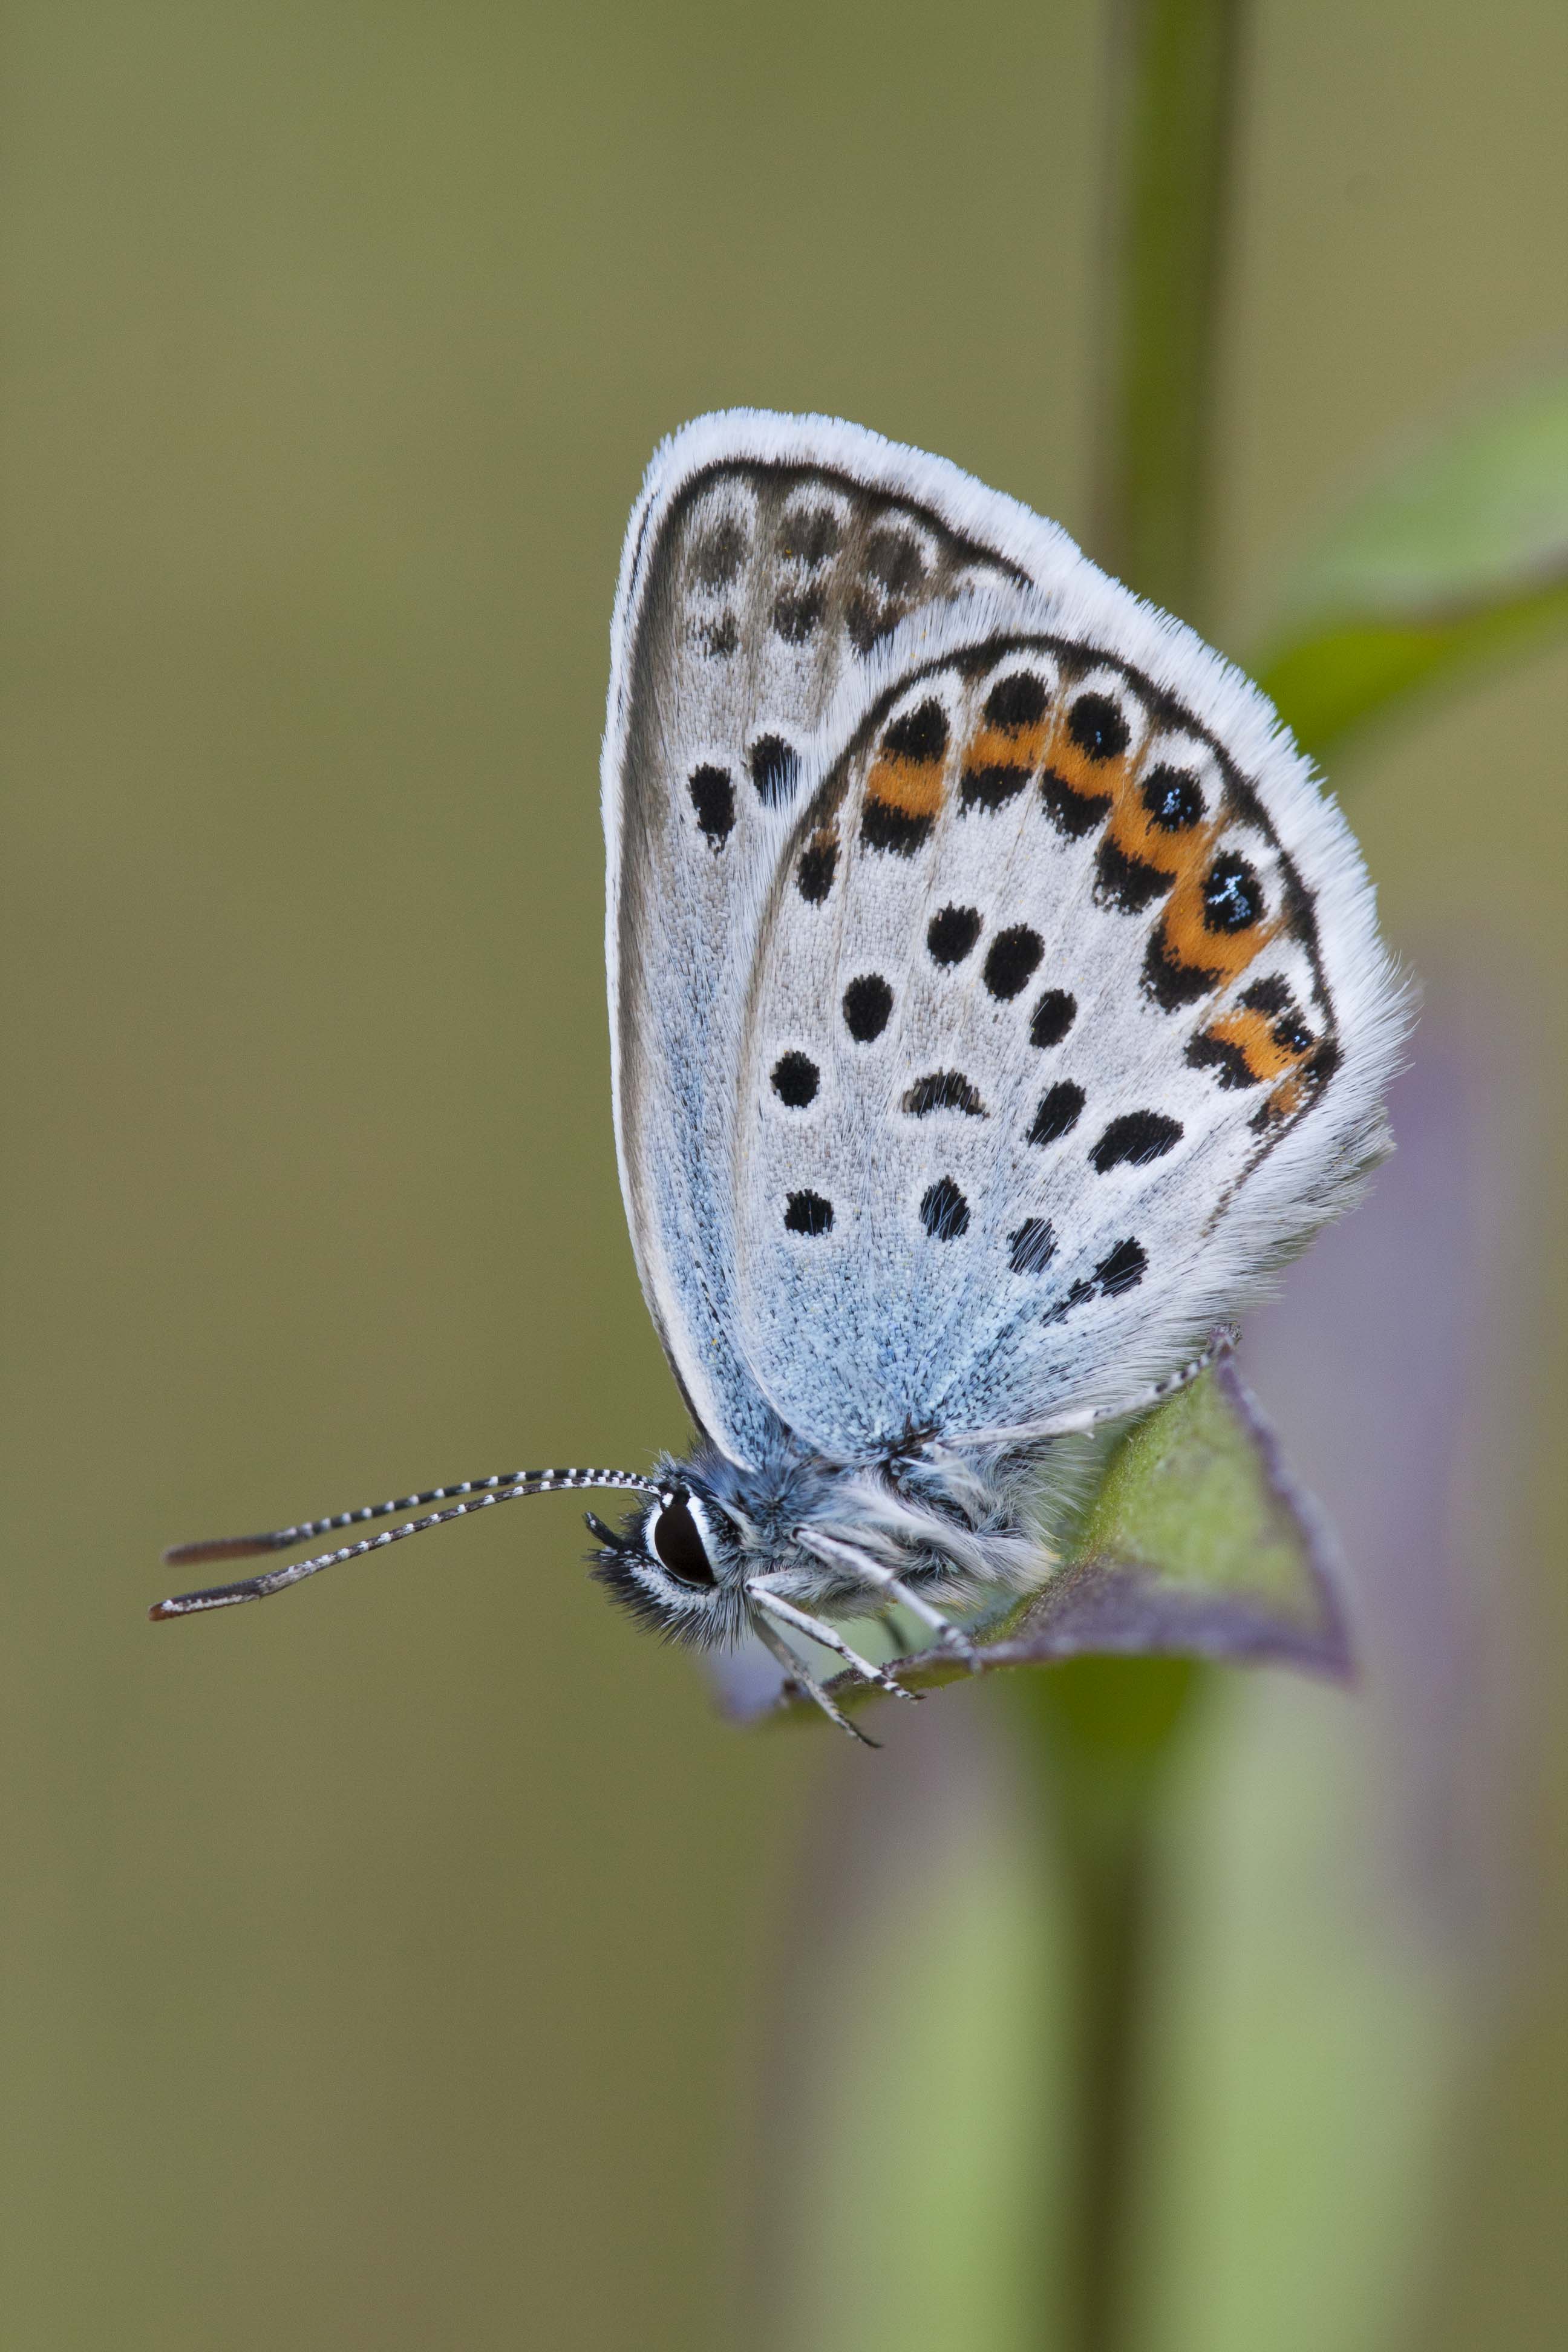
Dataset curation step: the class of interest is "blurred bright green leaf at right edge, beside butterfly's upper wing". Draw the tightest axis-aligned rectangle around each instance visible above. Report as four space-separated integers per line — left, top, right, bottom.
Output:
1250 381 1568 760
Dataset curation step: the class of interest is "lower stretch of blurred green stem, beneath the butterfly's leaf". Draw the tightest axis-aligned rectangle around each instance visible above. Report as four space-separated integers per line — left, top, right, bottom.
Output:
1022 1658 1199 2352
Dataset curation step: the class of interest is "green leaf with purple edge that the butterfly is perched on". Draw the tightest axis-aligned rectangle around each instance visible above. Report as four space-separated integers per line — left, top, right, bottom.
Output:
736 1362 1351 1712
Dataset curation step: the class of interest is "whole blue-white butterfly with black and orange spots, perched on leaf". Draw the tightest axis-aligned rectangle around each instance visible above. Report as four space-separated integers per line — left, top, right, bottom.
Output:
153 410 1408 1731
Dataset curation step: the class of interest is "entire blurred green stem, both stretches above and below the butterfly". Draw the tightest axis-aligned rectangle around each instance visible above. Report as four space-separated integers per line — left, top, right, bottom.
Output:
1027 0 1244 2352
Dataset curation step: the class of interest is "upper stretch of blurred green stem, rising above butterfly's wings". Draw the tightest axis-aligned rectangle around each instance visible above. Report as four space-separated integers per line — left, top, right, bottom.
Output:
1091 0 1244 626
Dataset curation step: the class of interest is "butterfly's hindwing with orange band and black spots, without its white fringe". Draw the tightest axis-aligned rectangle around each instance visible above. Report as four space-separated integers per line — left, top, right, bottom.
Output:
738 633 1382 1454
